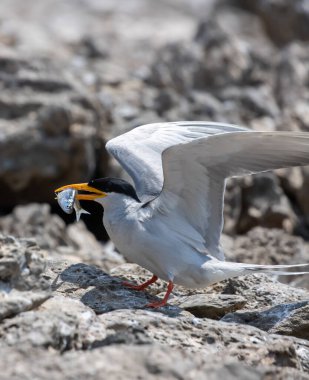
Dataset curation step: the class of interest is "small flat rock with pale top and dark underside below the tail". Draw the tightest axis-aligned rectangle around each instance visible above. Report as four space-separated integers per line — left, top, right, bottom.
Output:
170 294 246 319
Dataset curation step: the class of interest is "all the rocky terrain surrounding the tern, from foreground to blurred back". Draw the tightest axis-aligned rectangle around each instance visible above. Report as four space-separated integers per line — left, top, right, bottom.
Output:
0 0 309 379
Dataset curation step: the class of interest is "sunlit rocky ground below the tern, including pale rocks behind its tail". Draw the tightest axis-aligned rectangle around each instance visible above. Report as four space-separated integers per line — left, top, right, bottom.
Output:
0 204 309 379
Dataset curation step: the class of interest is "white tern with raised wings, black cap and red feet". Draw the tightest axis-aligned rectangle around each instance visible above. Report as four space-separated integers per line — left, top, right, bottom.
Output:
56 121 309 307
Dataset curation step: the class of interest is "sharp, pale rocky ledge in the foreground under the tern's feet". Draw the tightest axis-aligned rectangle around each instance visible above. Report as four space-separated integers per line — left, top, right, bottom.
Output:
0 238 309 379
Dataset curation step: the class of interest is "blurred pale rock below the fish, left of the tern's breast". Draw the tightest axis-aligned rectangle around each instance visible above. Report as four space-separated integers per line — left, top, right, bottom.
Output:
0 203 124 270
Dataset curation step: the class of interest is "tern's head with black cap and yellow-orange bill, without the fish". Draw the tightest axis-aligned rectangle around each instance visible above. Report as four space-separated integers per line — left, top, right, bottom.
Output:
55 178 139 202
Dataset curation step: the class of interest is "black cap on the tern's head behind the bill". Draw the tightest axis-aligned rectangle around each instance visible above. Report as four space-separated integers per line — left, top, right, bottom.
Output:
88 177 140 202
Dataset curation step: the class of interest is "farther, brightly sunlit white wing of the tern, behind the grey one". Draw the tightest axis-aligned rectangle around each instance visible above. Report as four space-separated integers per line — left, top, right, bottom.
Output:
106 121 247 202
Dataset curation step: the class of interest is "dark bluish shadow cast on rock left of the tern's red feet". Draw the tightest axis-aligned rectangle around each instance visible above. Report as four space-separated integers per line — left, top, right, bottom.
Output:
52 263 182 317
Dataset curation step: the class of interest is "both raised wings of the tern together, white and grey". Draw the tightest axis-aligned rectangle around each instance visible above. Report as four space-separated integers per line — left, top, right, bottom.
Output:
106 122 309 259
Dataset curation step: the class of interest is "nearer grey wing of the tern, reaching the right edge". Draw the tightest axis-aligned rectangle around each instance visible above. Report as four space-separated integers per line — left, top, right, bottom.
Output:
152 131 309 259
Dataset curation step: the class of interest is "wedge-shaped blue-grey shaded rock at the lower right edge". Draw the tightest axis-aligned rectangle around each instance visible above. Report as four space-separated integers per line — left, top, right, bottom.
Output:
221 301 309 339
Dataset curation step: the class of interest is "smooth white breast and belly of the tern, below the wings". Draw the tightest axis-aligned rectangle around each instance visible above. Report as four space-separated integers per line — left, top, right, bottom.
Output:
100 195 217 288
